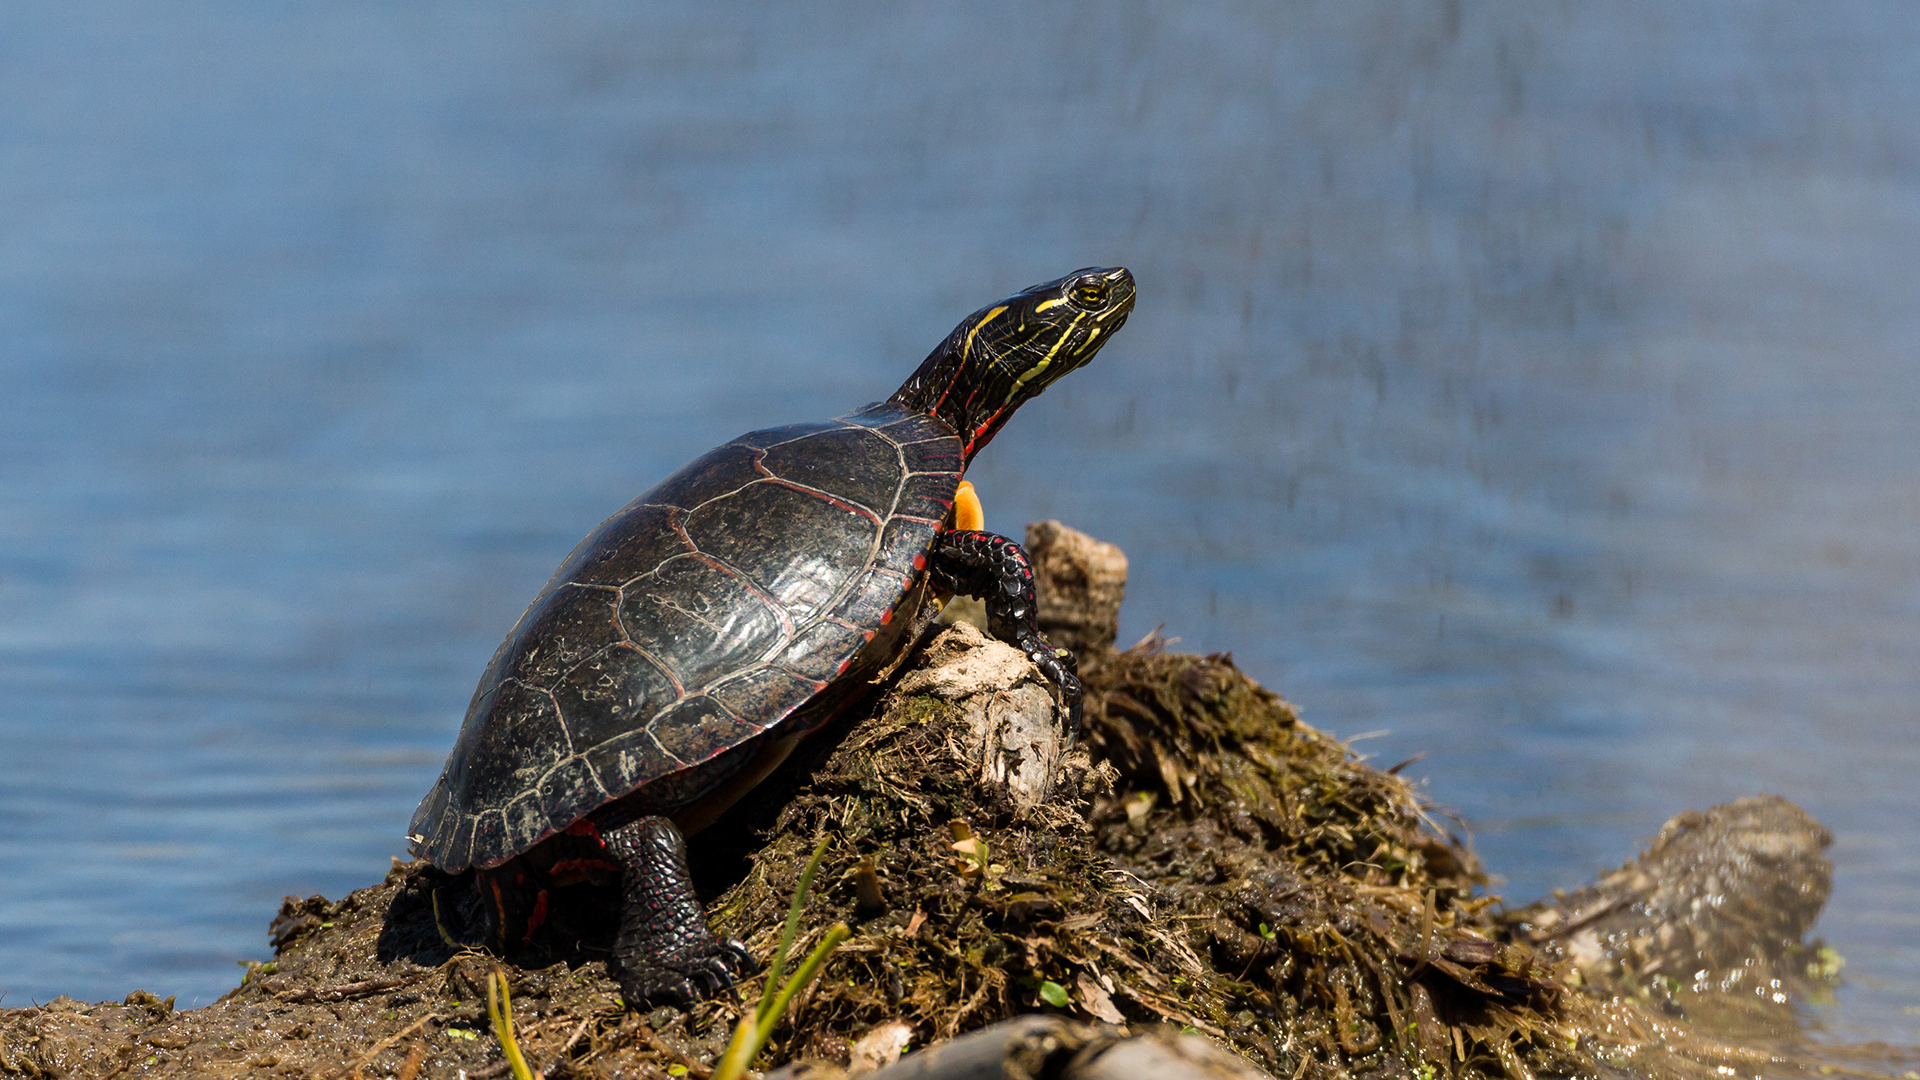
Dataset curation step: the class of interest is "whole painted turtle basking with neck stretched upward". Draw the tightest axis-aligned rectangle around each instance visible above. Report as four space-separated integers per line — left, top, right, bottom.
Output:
409 269 1133 1007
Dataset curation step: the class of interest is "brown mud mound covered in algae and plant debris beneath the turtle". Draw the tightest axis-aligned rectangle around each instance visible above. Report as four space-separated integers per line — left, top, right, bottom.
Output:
0 522 1899 1080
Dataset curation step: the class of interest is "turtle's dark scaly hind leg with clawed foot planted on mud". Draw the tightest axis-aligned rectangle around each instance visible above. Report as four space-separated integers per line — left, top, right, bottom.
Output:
601 817 758 1009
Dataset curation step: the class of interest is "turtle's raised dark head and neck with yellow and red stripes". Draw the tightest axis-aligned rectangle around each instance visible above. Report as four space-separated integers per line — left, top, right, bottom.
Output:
891 267 1133 463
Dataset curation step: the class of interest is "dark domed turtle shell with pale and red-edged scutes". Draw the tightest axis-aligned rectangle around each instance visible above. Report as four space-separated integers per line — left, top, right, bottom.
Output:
409 404 964 872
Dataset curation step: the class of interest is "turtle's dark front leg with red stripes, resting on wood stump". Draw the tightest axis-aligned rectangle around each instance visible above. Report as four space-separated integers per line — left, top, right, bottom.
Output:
927 528 1081 746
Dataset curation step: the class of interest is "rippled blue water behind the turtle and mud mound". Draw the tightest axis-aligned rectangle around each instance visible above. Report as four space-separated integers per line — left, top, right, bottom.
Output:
0 0 1920 1042
